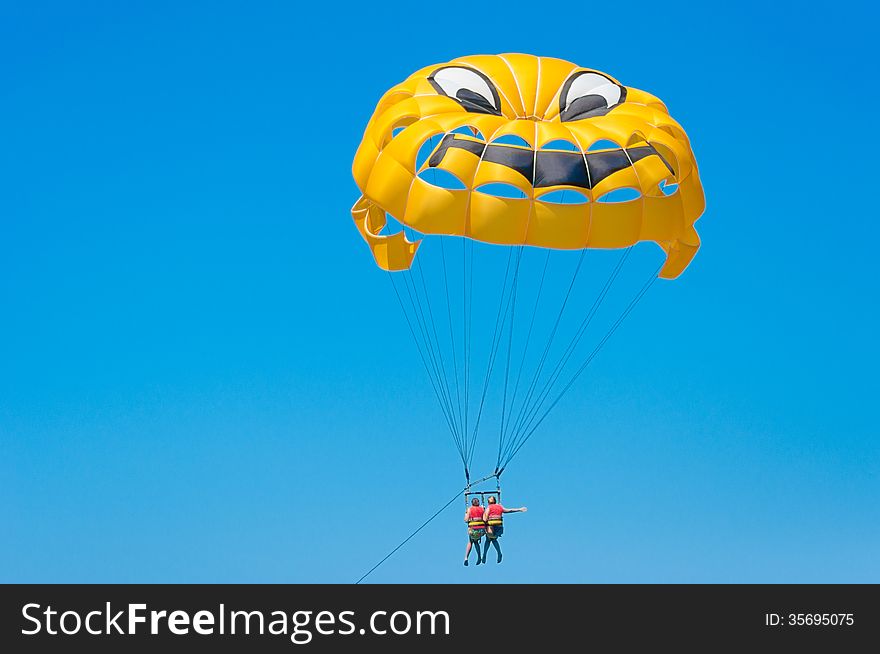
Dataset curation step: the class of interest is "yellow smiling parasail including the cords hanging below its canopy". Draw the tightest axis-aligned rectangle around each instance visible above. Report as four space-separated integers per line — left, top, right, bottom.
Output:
352 54 705 484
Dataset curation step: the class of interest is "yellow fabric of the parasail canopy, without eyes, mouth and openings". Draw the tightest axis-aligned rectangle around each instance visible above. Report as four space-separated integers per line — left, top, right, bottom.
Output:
352 54 705 277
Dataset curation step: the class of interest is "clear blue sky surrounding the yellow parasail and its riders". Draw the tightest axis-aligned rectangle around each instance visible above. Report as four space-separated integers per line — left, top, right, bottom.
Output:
0 2 880 583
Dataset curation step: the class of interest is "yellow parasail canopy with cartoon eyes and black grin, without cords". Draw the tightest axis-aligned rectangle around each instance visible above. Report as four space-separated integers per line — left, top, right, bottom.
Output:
352 54 705 278
